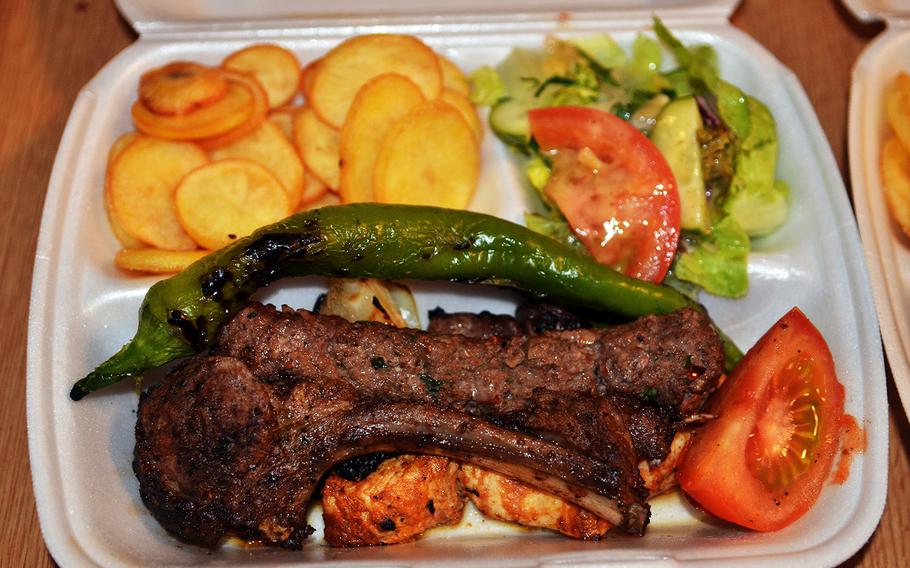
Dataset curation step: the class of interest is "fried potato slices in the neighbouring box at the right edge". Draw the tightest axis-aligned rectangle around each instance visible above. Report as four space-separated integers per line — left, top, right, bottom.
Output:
881 71 910 236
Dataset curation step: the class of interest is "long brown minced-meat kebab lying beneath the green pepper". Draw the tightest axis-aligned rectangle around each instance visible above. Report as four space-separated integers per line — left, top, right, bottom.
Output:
214 306 724 415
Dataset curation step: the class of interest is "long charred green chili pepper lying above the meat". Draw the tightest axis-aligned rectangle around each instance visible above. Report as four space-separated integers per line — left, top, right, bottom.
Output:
70 204 742 400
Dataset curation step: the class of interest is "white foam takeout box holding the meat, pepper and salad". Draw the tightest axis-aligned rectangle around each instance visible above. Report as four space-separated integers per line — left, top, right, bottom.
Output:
28 0 892 566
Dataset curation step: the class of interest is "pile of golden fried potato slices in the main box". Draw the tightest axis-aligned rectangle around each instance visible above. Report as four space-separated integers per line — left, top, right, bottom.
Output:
104 34 483 272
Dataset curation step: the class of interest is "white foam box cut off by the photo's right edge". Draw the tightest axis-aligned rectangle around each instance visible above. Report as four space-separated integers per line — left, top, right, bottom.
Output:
846 0 910 422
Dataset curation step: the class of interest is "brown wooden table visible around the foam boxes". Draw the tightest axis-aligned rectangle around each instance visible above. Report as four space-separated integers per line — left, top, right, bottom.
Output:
0 0 910 566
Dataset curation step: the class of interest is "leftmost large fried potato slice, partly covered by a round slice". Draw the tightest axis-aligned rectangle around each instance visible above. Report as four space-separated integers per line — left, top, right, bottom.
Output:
108 135 209 250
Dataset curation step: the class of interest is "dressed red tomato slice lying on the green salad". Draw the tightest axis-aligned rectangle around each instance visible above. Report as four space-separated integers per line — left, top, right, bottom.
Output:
529 107 679 282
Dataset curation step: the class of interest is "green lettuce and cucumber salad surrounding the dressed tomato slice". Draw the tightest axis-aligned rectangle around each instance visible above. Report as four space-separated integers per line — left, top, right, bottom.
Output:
470 18 789 297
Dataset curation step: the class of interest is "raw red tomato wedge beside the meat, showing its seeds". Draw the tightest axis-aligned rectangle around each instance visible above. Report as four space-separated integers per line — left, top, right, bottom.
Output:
676 308 844 531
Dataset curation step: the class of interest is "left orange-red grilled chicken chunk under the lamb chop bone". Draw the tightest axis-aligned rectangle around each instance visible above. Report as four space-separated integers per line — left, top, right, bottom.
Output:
322 454 464 546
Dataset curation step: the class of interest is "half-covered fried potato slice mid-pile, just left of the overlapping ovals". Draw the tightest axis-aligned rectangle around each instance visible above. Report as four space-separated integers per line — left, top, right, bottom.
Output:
294 106 341 189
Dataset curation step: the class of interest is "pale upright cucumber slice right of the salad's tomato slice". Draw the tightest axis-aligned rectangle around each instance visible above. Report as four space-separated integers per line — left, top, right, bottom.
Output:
651 97 711 232
